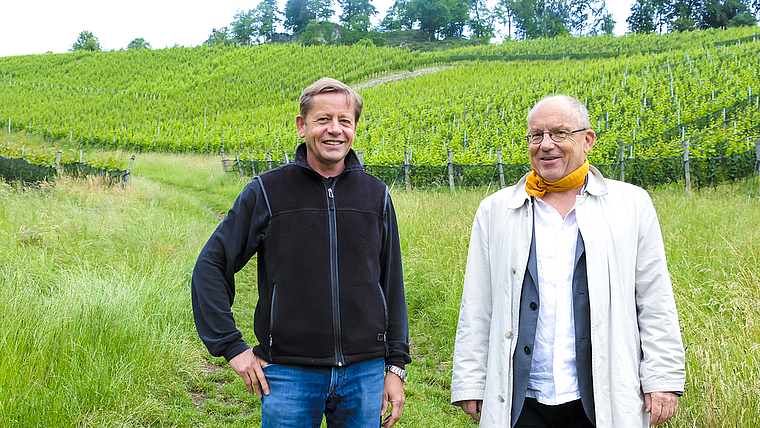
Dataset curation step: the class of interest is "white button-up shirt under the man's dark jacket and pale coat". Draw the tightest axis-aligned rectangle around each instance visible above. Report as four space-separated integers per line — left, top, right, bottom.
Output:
526 198 581 406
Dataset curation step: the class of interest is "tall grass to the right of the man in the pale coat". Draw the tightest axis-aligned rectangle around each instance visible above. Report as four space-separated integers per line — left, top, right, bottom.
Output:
654 185 760 427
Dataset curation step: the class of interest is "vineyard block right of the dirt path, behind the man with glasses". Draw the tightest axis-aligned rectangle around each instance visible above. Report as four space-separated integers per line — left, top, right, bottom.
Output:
357 33 760 163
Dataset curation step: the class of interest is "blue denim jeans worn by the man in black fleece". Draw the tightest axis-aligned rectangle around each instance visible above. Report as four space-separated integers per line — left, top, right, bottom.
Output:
261 358 385 428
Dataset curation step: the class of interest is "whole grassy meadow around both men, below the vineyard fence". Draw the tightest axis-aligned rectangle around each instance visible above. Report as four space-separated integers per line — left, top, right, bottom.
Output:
0 154 760 428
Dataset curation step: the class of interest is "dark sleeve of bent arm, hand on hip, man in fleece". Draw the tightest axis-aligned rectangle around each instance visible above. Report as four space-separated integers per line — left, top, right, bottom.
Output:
191 179 271 361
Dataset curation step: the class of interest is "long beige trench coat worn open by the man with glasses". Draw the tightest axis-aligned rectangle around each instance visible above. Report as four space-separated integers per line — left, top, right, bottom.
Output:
451 167 685 428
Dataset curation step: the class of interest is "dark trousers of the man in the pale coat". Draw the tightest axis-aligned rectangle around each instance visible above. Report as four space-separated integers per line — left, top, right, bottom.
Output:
515 397 594 428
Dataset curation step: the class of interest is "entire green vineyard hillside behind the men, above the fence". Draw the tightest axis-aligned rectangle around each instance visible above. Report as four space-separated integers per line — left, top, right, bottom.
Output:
0 27 760 181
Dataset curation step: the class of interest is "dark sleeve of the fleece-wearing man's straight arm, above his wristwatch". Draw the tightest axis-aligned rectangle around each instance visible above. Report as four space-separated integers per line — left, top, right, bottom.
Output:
380 191 412 368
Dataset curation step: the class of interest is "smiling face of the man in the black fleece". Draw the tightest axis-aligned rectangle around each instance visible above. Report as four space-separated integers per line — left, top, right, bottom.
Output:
296 92 356 177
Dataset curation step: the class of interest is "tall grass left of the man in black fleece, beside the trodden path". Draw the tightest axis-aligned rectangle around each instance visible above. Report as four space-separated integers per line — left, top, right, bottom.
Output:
0 172 226 426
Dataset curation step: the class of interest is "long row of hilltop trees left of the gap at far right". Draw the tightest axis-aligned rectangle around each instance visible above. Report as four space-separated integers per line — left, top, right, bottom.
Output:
206 0 624 46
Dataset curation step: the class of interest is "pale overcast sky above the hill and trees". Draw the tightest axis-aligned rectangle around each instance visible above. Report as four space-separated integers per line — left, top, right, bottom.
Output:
0 0 634 56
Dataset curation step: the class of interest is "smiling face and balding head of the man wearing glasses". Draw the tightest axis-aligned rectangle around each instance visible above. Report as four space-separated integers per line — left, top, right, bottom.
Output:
528 98 596 183
